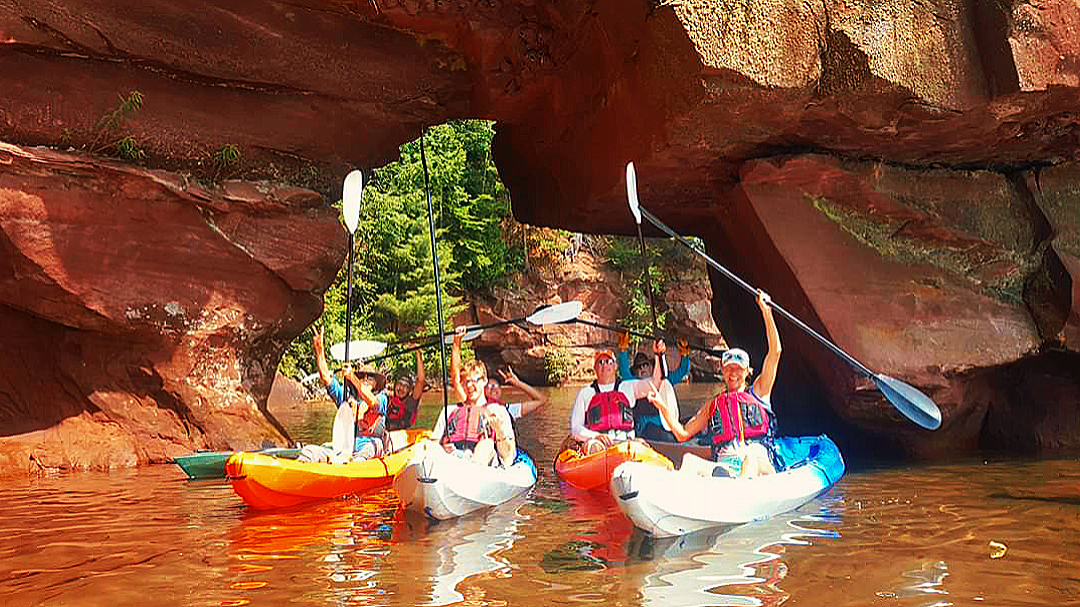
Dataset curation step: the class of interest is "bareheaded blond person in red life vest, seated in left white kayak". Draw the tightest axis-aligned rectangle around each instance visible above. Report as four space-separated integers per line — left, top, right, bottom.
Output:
432 326 517 468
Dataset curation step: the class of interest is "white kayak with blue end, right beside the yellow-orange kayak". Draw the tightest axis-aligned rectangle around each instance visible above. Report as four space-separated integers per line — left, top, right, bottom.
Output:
394 441 537 521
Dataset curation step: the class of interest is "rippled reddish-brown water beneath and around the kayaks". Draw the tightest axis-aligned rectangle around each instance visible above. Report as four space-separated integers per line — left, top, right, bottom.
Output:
0 386 1080 607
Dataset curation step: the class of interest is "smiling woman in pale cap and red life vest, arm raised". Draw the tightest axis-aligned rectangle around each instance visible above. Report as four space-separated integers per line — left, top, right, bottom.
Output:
648 289 781 477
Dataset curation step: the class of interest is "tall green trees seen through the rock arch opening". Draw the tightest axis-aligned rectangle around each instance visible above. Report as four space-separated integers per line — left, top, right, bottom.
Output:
280 120 524 381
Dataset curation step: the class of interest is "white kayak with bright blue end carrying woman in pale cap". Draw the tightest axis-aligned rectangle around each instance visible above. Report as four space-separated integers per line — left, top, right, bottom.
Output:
611 434 845 537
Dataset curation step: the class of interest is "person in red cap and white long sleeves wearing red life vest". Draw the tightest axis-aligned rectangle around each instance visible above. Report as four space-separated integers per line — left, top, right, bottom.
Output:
570 340 661 454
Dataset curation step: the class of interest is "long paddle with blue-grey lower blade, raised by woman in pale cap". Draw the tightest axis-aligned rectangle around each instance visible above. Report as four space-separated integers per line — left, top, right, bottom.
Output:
626 162 942 430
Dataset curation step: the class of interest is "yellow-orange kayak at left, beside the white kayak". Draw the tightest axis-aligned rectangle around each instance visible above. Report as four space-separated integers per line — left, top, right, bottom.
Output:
226 430 428 510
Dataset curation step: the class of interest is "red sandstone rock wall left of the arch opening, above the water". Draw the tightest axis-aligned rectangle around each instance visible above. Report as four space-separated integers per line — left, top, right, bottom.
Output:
0 144 345 471
